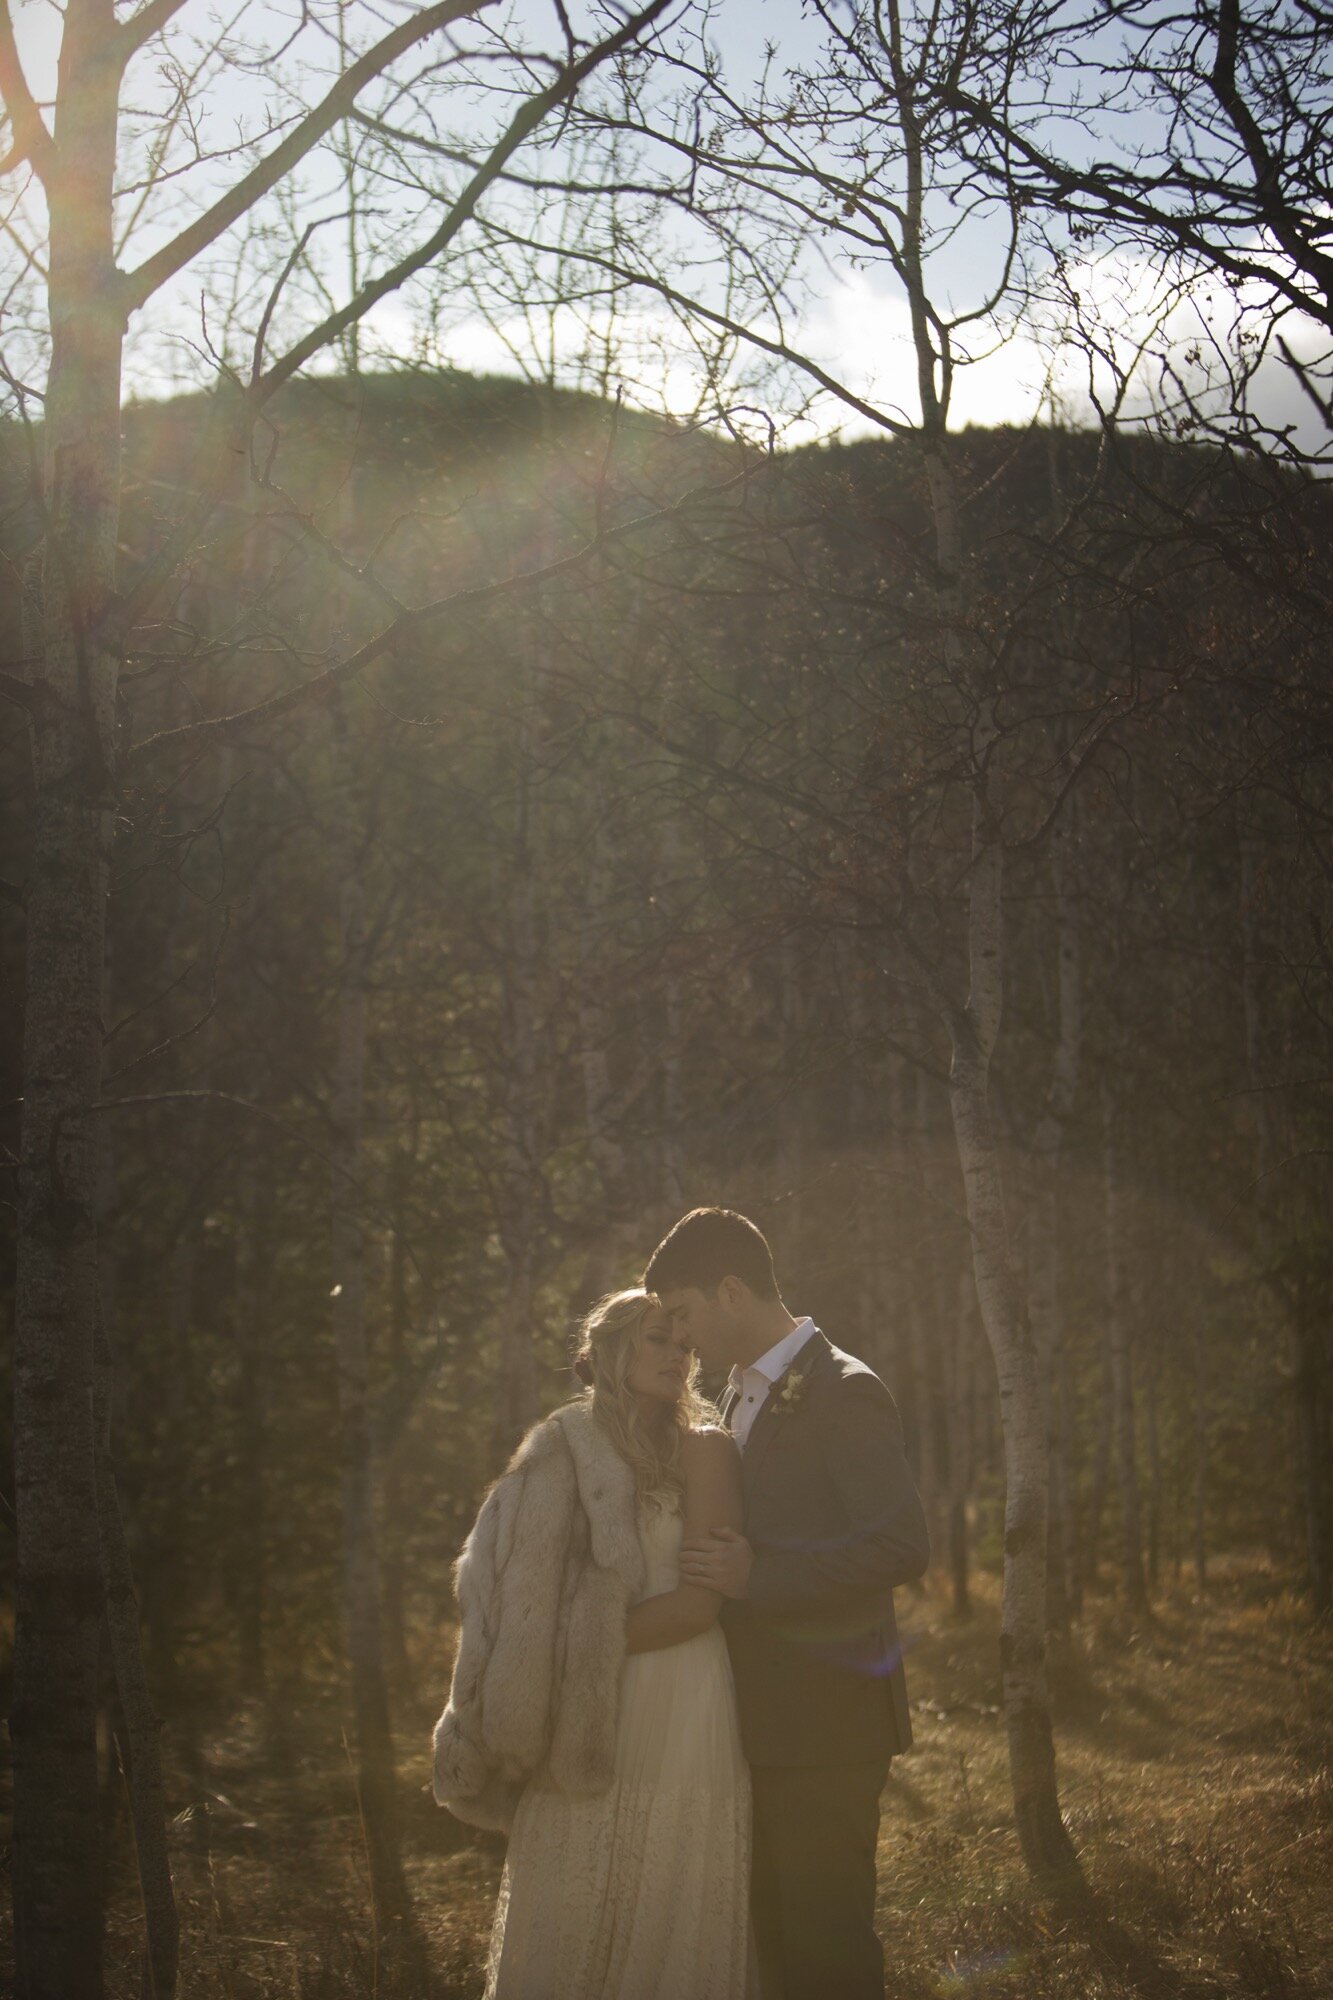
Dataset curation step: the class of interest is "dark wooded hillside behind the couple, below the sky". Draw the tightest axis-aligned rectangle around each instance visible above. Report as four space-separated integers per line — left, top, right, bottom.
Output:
2 378 1333 1968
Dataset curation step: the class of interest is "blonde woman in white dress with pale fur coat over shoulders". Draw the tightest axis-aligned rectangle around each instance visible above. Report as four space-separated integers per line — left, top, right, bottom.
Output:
434 1292 755 2000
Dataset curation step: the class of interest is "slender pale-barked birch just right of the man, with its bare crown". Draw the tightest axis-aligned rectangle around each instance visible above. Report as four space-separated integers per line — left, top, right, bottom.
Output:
520 4 1079 1878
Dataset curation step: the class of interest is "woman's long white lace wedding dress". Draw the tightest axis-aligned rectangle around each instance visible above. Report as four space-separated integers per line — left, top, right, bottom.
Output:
486 1508 755 2000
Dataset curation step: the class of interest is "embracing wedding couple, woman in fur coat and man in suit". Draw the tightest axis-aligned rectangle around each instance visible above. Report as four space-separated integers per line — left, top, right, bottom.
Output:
434 1208 929 2000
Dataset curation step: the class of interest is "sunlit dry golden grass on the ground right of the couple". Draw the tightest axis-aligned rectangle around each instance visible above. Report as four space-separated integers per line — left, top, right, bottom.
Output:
868 1570 1333 2000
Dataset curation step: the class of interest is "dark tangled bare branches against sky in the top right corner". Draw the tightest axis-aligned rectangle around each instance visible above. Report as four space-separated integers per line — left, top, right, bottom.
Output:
945 0 1333 470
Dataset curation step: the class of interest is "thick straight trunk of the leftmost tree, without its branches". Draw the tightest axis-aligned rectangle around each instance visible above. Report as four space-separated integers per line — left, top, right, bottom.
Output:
10 0 122 2000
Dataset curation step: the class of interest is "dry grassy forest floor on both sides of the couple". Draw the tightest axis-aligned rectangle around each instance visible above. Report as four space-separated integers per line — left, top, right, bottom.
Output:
96 1562 1333 2000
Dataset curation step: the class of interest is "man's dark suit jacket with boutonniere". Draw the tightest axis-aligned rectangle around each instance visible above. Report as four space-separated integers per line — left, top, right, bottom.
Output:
723 1330 931 1764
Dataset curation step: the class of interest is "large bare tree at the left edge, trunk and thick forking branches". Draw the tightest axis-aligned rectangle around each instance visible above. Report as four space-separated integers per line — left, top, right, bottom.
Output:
0 0 667 2000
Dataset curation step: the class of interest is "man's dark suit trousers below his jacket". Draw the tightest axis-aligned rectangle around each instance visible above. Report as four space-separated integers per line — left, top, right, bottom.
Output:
751 1758 889 2000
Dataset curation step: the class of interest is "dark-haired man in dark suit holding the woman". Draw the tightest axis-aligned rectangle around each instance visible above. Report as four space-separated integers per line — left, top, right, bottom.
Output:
642 1208 929 2000
